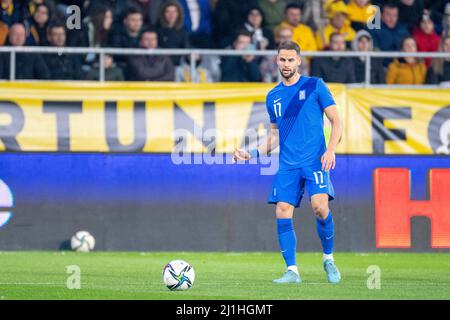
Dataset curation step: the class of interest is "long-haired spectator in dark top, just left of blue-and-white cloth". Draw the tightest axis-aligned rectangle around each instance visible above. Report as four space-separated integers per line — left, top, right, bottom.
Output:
158 0 189 66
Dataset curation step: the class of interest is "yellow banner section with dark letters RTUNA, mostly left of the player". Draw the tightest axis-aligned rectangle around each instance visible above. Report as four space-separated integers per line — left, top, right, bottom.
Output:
0 82 344 153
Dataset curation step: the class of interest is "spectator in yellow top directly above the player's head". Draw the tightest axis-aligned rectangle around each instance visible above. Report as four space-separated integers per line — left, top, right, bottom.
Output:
280 4 317 51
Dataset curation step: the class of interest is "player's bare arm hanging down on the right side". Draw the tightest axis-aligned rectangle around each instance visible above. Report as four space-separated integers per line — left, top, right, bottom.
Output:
320 105 342 171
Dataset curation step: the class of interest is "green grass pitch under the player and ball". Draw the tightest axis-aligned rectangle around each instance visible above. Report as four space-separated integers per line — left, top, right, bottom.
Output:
0 252 450 300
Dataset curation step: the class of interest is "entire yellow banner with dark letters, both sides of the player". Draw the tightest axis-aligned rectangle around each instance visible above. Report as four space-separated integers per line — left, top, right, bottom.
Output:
0 82 450 154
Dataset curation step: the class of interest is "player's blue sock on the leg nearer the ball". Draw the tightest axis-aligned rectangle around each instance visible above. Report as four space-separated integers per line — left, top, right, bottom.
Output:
277 219 298 274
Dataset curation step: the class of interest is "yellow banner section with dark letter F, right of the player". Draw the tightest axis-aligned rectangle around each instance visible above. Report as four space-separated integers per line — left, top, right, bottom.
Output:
345 89 450 154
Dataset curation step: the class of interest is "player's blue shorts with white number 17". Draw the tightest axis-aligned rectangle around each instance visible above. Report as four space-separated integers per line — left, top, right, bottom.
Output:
267 163 334 208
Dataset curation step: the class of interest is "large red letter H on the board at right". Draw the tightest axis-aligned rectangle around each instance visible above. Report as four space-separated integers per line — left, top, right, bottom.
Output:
374 168 450 248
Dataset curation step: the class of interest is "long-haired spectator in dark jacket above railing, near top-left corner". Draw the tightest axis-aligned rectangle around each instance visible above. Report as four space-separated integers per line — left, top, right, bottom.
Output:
24 4 51 46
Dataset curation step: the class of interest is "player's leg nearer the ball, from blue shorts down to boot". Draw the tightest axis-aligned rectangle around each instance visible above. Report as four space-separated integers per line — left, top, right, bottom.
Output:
269 171 303 283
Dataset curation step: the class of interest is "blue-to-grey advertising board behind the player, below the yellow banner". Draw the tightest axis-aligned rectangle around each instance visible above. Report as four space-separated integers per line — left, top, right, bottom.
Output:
0 153 450 251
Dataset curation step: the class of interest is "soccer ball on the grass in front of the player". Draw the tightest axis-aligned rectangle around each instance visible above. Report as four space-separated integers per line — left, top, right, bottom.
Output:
163 260 195 290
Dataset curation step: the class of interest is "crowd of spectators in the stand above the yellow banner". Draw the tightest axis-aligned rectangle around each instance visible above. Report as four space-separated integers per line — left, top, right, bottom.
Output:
0 0 450 84
